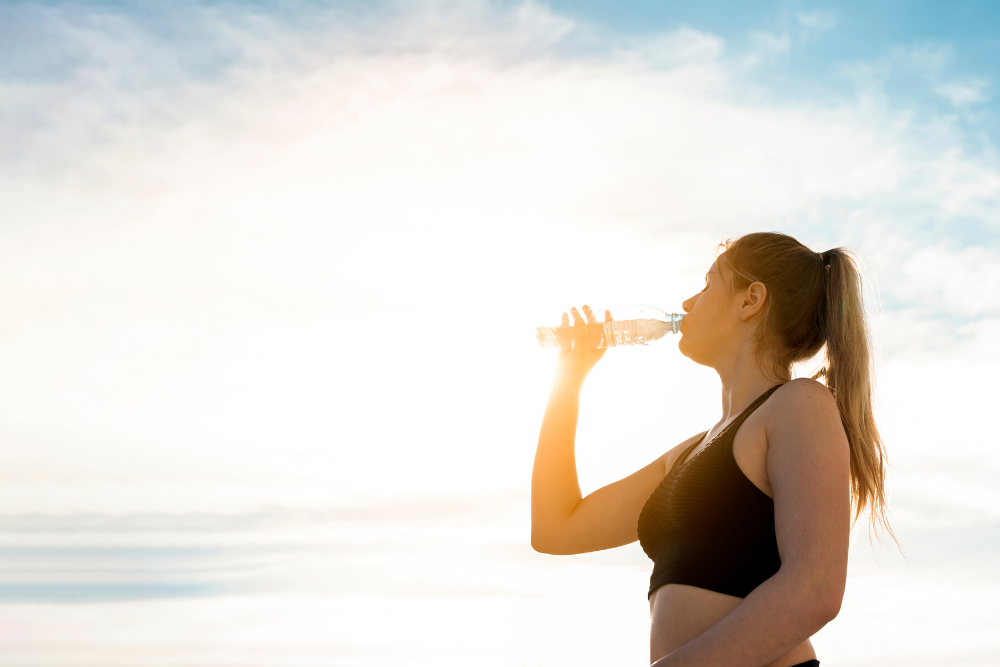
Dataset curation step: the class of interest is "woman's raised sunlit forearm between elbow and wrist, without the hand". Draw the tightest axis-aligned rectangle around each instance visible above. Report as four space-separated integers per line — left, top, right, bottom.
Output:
531 380 582 546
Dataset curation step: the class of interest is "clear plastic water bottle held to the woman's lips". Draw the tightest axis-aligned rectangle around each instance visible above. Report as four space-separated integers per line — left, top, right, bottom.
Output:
536 306 684 350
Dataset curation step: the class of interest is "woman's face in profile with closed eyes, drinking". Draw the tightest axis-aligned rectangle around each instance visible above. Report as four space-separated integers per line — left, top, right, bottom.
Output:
678 253 742 367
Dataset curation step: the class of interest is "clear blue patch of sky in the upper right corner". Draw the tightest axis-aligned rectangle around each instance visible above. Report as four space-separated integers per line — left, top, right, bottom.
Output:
549 0 1000 163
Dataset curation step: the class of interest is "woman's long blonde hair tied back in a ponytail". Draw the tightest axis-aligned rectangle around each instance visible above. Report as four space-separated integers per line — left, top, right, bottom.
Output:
722 232 895 540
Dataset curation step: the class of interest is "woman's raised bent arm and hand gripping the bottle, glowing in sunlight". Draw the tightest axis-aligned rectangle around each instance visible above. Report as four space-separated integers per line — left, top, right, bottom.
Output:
531 306 697 554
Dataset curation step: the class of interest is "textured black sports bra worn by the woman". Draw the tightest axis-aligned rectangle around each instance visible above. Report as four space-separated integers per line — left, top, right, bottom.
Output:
639 385 781 598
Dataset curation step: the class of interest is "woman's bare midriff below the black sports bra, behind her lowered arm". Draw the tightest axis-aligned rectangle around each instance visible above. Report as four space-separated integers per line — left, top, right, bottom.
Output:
649 584 816 667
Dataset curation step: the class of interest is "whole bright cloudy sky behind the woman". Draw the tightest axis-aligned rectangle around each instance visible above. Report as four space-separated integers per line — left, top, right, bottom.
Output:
0 0 1000 667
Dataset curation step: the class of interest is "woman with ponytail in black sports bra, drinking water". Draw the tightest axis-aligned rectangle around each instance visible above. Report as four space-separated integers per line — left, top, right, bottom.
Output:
531 233 891 667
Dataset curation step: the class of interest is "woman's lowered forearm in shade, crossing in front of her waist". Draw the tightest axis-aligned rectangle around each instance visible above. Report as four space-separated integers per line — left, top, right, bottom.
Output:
652 572 839 667
